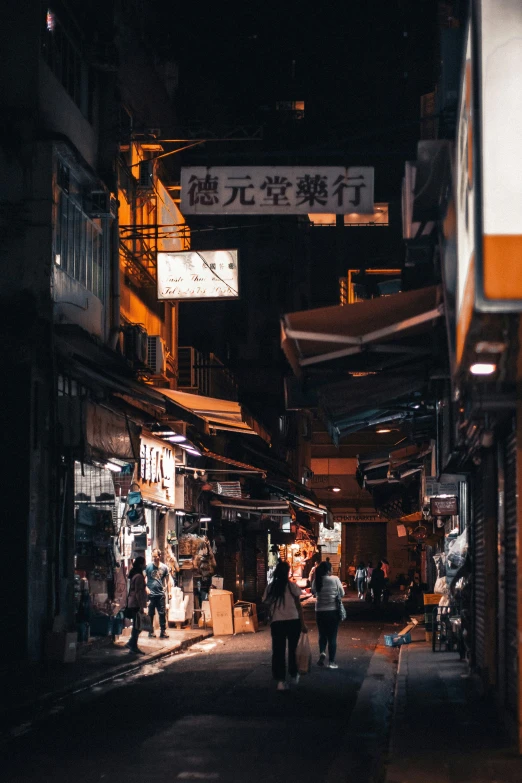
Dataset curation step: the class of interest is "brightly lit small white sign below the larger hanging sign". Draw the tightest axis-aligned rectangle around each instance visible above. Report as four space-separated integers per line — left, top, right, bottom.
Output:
158 250 239 299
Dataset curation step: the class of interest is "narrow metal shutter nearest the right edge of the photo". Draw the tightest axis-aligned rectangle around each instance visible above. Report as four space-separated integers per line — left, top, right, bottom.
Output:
504 432 518 715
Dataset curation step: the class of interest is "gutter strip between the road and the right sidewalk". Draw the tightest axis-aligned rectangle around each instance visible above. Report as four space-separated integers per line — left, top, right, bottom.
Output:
325 631 400 783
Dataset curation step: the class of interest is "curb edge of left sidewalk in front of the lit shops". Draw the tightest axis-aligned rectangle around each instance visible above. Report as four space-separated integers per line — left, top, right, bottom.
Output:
0 632 214 744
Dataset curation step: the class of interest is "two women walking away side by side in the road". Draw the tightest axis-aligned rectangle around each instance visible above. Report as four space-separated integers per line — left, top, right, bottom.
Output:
263 560 344 691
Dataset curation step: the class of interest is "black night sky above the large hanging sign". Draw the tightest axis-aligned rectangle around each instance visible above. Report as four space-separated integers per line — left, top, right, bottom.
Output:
162 0 437 146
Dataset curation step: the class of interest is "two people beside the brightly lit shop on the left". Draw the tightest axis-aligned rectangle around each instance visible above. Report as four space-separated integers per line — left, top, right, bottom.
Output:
126 549 169 655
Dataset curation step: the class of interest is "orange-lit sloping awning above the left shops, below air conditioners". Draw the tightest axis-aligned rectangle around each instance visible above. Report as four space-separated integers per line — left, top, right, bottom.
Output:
155 388 270 443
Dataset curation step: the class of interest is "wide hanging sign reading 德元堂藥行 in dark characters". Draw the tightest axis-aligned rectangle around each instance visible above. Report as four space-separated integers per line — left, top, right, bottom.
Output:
181 166 374 215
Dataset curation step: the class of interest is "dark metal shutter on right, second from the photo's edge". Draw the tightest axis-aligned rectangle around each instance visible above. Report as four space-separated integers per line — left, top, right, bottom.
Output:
473 463 486 671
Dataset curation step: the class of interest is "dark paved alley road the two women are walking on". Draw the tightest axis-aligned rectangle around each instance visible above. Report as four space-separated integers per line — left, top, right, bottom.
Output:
2 601 398 783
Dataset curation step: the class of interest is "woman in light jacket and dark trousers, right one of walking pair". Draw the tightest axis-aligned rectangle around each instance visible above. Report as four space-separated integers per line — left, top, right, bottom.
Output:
312 562 344 669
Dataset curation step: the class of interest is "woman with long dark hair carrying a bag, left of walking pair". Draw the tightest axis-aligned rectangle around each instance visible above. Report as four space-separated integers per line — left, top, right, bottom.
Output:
263 560 308 691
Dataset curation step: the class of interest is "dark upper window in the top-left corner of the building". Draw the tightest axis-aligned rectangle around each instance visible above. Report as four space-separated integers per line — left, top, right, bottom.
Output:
42 8 90 118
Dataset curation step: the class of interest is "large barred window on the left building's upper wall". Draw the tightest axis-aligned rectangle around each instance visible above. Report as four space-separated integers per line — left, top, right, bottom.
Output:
55 163 108 302
